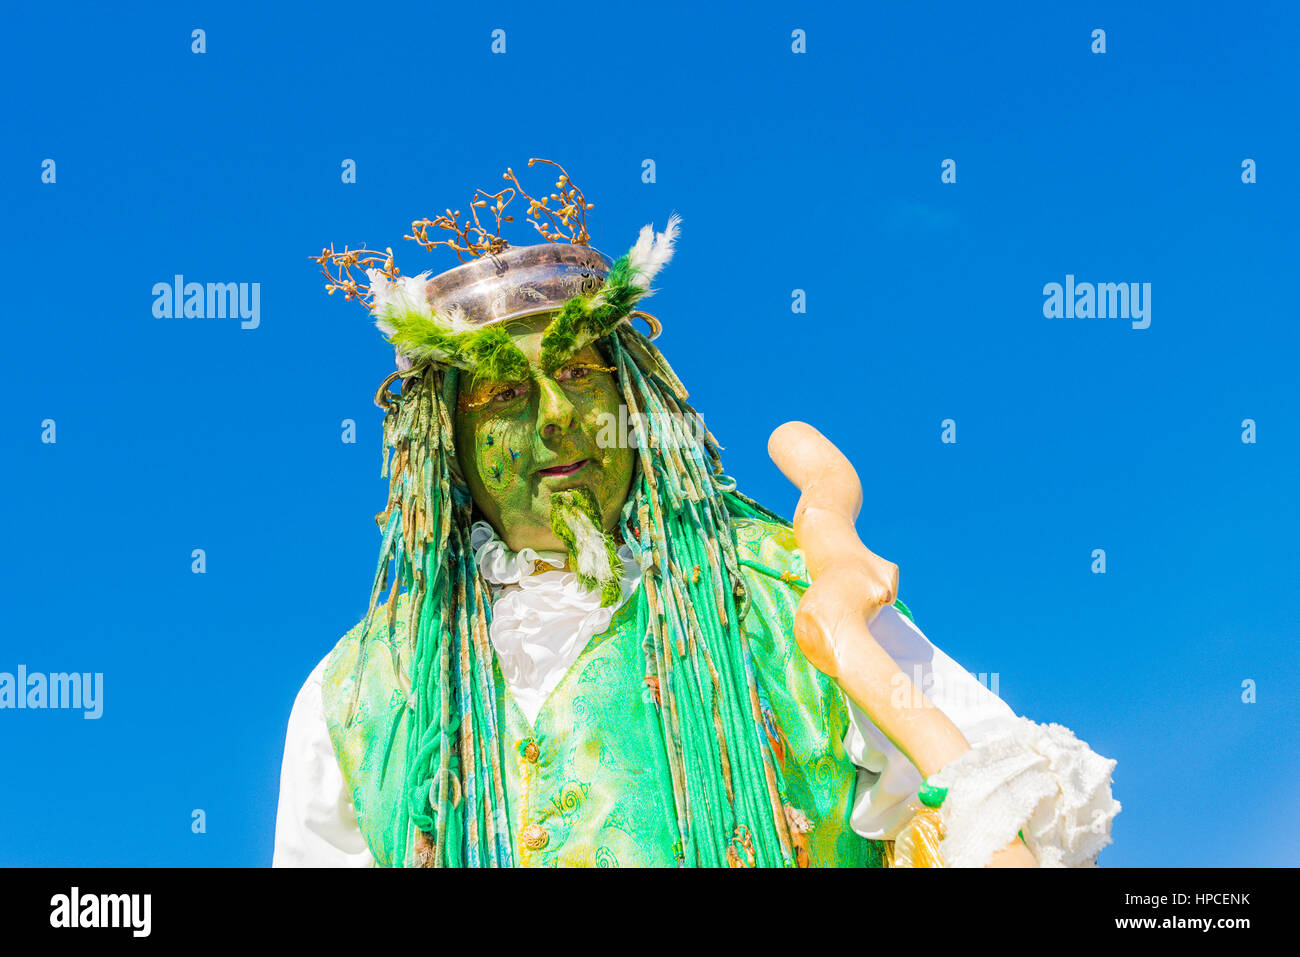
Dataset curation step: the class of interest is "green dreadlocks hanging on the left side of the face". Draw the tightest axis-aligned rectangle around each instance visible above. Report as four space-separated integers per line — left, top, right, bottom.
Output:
355 368 514 867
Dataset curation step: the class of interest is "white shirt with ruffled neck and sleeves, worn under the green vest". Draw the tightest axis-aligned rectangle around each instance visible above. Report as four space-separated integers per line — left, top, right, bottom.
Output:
272 523 1017 867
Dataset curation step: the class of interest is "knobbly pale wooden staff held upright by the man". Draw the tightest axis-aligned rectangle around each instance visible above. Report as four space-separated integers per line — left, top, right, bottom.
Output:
767 423 1036 867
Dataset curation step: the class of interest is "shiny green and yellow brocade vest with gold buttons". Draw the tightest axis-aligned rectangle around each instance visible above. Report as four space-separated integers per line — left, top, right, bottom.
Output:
324 519 883 867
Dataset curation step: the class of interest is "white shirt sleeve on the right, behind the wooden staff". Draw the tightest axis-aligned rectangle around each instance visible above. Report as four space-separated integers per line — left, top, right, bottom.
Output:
844 606 1015 840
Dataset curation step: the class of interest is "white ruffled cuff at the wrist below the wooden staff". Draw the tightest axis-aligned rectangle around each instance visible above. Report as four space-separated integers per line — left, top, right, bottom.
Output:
928 718 1119 867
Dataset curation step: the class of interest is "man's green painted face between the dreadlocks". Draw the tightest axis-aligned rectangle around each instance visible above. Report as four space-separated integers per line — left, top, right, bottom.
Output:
455 313 636 551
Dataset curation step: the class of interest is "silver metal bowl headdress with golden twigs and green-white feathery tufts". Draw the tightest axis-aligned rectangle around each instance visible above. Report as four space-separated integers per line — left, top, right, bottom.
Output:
315 159 680 381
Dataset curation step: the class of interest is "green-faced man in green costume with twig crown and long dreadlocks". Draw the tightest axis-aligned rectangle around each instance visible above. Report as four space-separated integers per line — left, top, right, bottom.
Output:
276 163 1118 867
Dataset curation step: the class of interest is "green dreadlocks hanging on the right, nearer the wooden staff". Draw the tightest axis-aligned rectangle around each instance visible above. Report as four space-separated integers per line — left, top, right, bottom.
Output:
608 326 792 866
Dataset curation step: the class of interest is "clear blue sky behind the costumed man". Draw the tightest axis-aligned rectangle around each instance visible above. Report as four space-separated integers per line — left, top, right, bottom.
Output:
0 3 1300 866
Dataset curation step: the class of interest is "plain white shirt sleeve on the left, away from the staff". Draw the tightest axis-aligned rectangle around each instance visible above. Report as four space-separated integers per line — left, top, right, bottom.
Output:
272 655 374 867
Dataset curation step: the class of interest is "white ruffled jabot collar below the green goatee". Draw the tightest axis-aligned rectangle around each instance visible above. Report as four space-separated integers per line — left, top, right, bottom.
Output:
469 521 641 724
